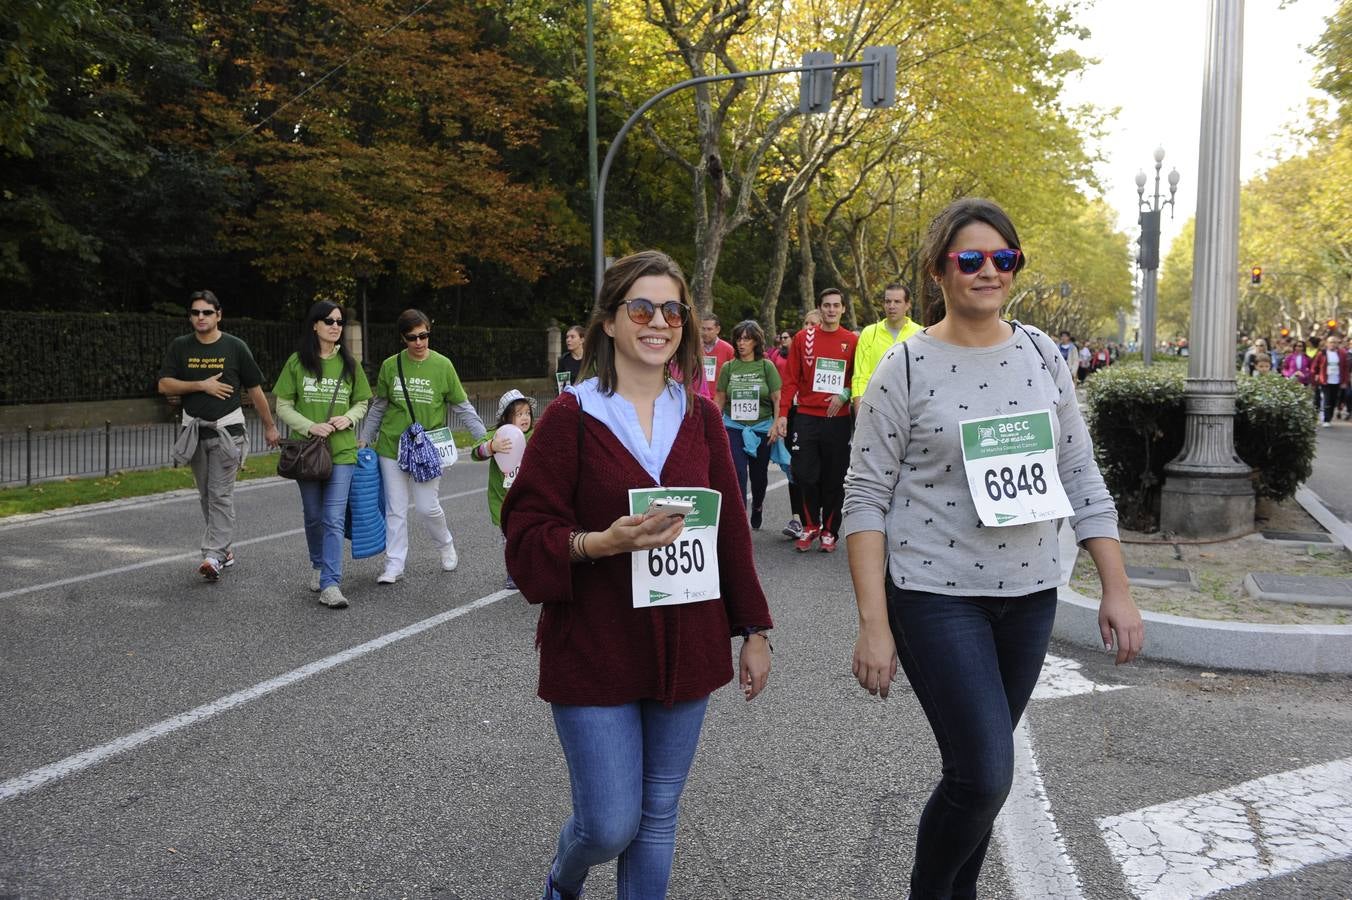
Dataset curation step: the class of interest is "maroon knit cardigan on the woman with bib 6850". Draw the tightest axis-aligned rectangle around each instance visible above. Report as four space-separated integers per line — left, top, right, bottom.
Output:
502 392 771 705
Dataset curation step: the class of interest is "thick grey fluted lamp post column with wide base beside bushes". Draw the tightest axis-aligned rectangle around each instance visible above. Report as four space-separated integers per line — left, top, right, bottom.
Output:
1160 0 1253 538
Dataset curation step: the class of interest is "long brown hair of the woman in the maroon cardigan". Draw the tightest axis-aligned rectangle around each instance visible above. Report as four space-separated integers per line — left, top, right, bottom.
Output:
581 250 703 412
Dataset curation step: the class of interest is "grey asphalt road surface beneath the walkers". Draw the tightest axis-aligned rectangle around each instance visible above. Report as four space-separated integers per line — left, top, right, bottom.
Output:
0 451 1352 900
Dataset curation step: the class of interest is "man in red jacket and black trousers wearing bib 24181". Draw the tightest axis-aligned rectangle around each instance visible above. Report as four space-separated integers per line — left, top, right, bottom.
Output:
772 288 859 553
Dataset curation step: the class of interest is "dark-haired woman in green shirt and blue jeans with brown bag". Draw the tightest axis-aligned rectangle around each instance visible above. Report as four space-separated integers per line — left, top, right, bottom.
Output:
273 300 370 609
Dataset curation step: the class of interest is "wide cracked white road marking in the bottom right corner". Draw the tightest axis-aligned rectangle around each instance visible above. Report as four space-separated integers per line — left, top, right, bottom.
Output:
1098 757 1352 900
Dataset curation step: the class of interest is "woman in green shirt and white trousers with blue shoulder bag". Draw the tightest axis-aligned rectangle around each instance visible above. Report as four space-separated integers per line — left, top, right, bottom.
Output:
361 309 488 584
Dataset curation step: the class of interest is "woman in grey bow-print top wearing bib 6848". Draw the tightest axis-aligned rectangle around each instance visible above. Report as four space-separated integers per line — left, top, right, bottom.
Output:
841 199 1144 899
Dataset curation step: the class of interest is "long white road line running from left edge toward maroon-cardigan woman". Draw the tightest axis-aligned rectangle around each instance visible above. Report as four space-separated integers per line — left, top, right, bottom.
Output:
0 591 516 803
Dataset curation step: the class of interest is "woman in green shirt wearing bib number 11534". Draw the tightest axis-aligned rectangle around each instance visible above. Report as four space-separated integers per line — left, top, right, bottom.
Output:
714 319 781 530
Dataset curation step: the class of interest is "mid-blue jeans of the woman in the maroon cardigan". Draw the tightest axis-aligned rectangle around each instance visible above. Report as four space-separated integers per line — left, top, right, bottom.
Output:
552 697 708 900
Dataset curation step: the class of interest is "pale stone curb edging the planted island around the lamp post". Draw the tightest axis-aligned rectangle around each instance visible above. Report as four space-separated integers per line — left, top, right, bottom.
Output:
1052 508 1352 674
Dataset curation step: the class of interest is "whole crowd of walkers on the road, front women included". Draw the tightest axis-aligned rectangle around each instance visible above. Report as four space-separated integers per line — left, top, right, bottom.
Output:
161 199 1151 900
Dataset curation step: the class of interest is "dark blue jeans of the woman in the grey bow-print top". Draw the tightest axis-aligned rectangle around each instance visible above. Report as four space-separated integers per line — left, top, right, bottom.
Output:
887 577 1056 900
